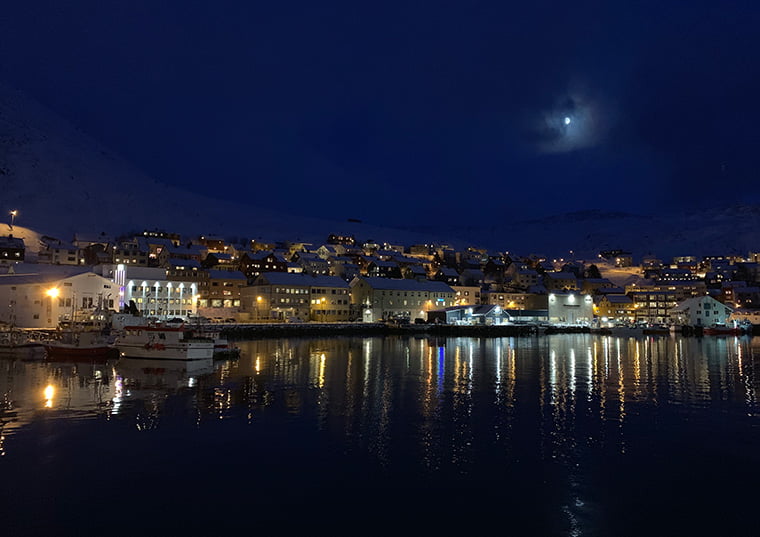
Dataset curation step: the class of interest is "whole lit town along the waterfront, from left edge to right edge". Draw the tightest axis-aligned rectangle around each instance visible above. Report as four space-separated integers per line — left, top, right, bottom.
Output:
0 216 760 333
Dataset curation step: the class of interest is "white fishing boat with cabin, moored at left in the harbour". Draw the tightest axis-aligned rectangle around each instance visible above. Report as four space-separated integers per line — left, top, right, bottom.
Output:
114 324 214 360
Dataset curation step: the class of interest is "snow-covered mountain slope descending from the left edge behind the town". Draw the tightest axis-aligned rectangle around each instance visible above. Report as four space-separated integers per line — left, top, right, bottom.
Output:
0 84 452 247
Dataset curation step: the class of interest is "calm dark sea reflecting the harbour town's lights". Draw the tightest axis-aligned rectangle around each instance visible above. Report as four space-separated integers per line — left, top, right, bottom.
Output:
0 334 760 536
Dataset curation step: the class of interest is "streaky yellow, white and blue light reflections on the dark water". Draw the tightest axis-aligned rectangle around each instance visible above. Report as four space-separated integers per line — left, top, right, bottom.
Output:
0 335 760 535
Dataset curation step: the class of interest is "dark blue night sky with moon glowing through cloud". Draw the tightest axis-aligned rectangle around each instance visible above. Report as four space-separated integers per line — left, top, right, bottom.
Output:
0 0 760 224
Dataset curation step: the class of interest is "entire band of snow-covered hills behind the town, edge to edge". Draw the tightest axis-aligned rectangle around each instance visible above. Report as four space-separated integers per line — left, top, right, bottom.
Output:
0 80 760 259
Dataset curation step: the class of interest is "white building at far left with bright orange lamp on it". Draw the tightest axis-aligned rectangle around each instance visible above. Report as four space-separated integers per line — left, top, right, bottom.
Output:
0 265 118 328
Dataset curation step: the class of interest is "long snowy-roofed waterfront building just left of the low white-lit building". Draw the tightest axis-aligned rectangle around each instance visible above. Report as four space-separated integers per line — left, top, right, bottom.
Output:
350 277 456 322
